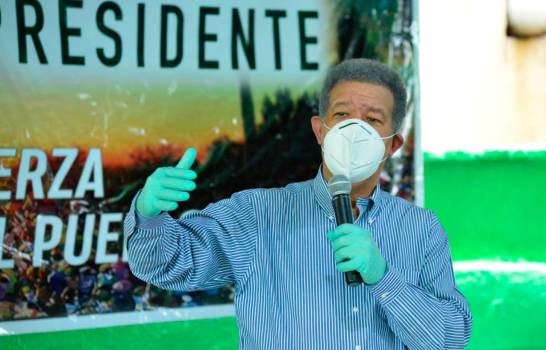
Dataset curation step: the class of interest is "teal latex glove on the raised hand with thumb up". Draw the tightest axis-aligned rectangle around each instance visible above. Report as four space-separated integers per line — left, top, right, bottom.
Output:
136 148 197 217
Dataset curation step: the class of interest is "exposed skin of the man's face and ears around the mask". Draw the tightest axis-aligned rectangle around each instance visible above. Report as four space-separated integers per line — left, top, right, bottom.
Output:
311 81 404 180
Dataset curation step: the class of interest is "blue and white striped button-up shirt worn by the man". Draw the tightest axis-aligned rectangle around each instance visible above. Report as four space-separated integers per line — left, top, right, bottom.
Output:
124 171 472 350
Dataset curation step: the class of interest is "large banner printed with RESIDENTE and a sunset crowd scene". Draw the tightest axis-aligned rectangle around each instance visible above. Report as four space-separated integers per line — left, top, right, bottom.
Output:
0 0 417 328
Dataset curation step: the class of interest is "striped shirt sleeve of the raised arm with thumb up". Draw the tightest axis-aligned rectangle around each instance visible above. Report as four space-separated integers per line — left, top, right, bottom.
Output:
123 190 257 291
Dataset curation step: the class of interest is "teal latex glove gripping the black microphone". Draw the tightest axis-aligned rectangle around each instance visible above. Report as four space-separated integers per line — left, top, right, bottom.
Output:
328 224 387 284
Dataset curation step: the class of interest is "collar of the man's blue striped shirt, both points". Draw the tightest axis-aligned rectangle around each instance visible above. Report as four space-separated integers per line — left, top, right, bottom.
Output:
313 166 383 224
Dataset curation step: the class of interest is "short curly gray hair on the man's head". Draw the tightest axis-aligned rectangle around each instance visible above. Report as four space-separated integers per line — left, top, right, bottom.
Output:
319 58 406 132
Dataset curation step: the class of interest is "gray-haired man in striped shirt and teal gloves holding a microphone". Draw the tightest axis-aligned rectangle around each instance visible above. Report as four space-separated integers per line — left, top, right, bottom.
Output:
124 59 472 350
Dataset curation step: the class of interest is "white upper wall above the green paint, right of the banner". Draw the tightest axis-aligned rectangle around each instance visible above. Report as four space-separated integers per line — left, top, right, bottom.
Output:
419 0 546 153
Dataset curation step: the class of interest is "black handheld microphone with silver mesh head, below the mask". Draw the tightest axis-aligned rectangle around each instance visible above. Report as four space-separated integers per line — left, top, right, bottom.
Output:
328 175 363 287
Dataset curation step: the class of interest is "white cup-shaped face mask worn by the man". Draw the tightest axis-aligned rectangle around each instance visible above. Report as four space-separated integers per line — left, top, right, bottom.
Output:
322 119 396 183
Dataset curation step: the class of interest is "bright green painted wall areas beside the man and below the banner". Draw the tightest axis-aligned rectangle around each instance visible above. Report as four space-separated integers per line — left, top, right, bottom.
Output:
0 152 546 350
